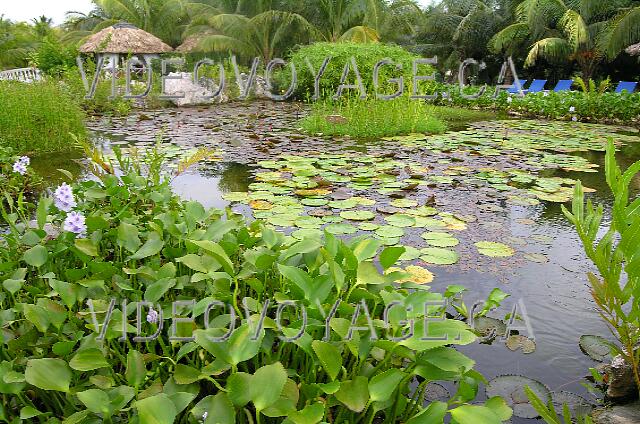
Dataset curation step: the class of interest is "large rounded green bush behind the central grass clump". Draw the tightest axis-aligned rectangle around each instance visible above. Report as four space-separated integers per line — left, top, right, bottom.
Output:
291 43 435 100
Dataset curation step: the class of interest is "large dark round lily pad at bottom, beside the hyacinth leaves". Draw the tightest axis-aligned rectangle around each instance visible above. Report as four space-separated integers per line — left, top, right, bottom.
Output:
486 375 551 418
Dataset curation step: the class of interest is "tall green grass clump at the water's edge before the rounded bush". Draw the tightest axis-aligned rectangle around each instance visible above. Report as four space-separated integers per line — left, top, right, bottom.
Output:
301 97 447 138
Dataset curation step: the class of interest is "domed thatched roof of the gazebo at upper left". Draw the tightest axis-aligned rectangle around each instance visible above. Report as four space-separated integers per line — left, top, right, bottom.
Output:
80 23 173 54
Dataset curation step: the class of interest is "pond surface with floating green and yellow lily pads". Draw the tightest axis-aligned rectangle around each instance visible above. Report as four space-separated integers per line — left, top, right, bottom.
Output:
47 102 640 422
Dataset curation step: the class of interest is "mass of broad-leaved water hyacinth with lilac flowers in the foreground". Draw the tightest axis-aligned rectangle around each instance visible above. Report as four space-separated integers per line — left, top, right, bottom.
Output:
0 144 511 424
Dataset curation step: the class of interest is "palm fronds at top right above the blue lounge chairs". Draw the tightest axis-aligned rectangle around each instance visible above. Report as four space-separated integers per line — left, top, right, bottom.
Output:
489 0 640 80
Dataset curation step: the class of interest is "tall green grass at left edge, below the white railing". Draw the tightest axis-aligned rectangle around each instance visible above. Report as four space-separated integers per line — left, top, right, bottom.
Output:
0 81 86 155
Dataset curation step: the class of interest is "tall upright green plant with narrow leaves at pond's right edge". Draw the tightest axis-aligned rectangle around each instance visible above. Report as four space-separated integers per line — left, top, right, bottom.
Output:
563 141 640 396
